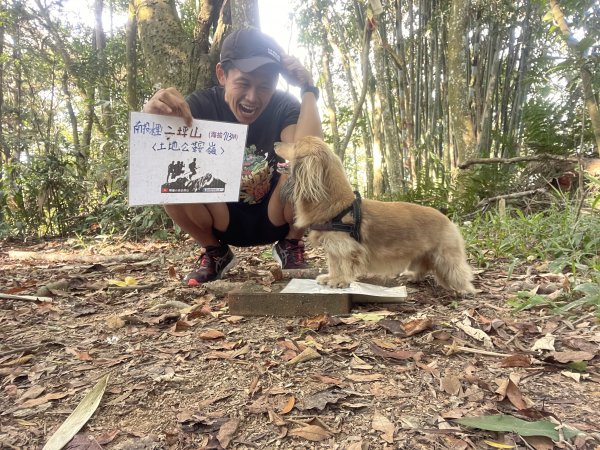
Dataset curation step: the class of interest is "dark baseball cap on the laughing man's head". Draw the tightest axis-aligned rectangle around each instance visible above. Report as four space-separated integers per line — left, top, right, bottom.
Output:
221 28 283 72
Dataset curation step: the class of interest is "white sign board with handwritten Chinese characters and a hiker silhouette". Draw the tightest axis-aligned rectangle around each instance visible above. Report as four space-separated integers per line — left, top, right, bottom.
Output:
129 112 248 206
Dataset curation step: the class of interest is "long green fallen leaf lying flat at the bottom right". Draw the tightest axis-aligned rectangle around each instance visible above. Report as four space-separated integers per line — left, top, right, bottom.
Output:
456 415 580 441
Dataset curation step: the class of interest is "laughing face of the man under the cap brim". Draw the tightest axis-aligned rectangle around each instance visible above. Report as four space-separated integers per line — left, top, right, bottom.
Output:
217 64 279 125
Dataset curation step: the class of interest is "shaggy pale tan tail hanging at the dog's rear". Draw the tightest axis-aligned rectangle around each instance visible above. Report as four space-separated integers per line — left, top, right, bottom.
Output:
433 222 475 294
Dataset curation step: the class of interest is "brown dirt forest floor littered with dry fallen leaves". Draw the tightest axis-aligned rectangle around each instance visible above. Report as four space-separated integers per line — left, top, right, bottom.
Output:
0 240 600 450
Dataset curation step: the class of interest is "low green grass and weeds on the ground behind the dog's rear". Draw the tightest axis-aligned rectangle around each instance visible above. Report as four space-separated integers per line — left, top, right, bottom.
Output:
463 204 600 316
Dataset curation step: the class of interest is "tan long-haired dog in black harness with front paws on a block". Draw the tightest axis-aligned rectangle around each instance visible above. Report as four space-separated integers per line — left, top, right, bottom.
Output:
275 137 474 294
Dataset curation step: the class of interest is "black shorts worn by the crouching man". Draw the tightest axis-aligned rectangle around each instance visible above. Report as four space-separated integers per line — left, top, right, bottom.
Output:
213 177 290 247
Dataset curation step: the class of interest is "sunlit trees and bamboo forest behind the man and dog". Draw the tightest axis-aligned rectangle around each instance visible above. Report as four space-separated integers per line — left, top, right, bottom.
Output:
0 0 600 238
